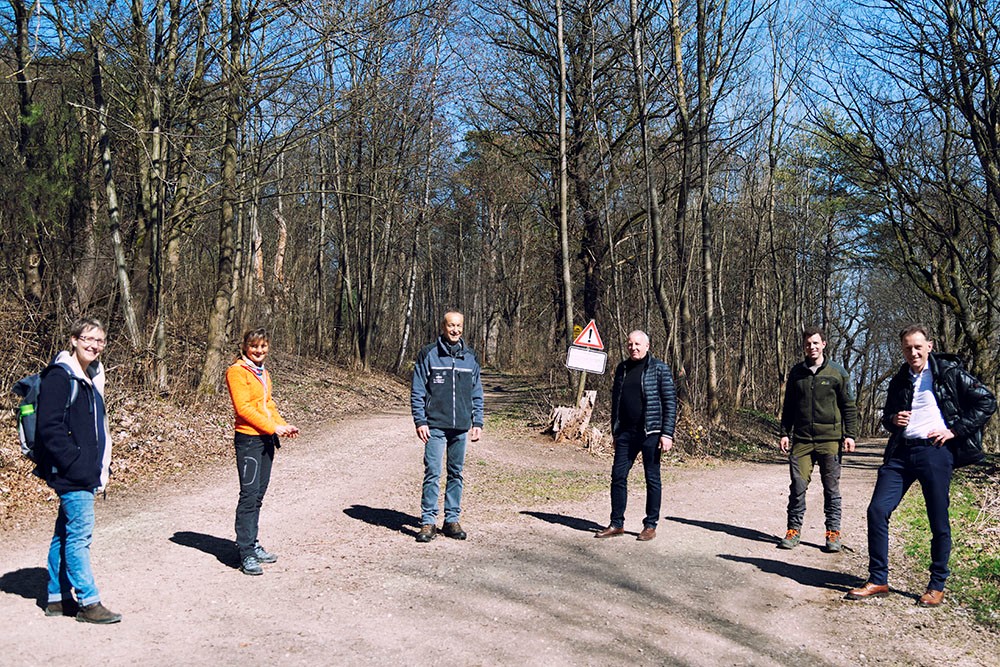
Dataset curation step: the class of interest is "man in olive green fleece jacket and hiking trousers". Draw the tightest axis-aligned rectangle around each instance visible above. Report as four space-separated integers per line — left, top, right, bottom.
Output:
778 327 858 552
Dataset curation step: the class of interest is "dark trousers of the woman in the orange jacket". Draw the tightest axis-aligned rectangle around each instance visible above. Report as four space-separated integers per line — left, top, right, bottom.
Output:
233 433 278 559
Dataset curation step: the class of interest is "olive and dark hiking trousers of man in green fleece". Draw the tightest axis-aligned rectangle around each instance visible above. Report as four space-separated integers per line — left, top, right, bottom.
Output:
788 441 841 531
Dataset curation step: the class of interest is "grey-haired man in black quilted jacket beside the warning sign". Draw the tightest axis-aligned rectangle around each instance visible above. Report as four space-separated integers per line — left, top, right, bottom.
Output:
594 331 677 542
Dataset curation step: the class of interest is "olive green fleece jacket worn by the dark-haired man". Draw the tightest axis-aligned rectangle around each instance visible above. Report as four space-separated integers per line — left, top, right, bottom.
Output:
781 359 858 442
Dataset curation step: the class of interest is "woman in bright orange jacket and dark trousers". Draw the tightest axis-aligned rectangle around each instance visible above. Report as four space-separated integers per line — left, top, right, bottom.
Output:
226 329 299 575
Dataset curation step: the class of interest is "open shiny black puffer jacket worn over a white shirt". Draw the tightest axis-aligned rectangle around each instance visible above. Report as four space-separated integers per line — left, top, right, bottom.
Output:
882 353 997 468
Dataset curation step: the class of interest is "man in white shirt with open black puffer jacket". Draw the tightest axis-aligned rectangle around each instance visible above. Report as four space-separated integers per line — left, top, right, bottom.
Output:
847 325 997 607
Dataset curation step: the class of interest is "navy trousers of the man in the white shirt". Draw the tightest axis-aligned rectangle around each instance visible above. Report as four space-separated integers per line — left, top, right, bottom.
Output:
868 444 954 591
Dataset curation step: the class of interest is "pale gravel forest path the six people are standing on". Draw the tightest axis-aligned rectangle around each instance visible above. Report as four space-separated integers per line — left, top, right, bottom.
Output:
0 400 1000 667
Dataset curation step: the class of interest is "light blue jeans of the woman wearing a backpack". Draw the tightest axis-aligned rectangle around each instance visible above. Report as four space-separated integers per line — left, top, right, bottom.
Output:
48 491 101 606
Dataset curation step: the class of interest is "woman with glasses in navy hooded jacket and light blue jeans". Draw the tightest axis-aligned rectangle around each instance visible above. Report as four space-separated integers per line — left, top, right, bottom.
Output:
36 318 122 623
